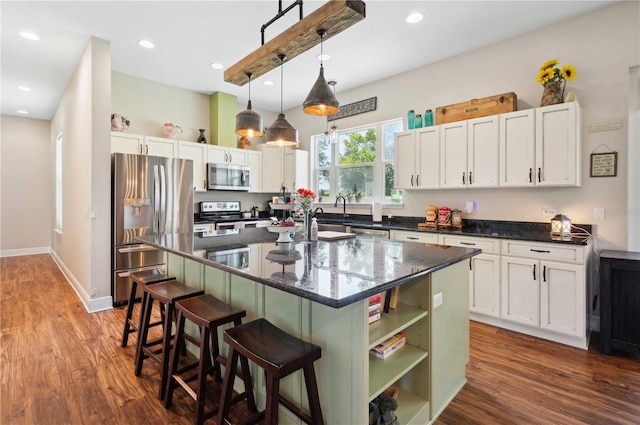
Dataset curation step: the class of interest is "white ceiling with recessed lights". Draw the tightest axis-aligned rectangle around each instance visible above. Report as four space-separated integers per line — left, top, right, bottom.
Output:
0 0 615 119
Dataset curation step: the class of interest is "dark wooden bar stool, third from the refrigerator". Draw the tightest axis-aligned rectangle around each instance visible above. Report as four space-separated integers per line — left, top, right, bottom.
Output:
164 294 257 425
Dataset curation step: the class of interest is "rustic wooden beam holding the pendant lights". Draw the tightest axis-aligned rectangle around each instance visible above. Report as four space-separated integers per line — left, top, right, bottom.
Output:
224 0 365 86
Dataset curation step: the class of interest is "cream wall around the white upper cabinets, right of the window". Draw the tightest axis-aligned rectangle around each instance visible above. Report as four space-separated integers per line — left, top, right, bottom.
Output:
286 2 640 249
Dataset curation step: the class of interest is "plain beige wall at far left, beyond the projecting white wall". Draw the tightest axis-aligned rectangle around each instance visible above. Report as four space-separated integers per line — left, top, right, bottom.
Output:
0 115 55 256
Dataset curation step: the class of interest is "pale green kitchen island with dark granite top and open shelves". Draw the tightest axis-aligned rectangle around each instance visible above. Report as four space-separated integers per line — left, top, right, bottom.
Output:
140 228 480 424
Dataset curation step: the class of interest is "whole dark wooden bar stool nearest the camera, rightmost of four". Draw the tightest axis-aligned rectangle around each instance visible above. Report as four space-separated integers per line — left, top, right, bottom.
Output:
218 319 324 425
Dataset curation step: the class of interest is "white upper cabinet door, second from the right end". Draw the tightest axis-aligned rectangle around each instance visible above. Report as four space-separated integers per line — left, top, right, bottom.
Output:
498 109 537 187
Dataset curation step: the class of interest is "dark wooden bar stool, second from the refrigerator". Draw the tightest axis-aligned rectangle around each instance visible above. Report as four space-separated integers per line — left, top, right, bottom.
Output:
135 280 204 400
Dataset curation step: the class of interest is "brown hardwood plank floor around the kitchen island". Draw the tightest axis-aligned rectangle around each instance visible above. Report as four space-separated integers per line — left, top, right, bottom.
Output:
0 255 640 425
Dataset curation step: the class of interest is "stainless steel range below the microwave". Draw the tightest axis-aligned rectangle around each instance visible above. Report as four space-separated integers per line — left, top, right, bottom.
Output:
193 201 270 236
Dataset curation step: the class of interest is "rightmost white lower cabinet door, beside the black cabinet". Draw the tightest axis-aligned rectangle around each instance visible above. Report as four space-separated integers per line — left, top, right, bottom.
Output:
540 261 586 336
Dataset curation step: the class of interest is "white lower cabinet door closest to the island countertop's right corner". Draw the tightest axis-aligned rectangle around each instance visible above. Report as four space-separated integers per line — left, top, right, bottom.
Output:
469 254 500 317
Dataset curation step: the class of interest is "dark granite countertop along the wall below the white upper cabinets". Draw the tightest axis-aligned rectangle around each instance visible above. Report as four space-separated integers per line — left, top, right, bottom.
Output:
319 214 592 245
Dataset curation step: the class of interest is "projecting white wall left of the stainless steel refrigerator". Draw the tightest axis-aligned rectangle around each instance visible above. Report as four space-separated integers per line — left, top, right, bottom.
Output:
50 38 111 311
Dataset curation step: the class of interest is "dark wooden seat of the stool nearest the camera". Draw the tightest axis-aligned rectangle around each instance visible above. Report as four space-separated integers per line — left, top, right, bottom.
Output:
224 319 321 378
